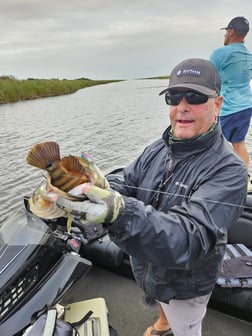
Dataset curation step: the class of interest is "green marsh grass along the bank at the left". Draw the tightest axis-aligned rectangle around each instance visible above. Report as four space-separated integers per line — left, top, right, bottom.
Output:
0 76 119 104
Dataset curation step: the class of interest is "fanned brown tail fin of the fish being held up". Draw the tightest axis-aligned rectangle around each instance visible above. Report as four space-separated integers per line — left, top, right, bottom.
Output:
26 141 60 170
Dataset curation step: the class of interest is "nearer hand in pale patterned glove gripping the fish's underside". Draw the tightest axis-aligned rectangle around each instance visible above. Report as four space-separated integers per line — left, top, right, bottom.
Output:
56 183 124 224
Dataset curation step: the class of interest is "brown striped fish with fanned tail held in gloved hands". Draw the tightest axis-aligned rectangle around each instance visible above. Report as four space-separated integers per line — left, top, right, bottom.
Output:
26 141 109 230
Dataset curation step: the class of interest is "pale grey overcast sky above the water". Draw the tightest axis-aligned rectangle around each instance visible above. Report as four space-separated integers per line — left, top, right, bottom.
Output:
0 0 252 79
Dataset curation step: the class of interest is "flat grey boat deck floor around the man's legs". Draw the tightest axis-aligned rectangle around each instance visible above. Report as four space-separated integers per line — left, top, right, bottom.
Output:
63 266 252 336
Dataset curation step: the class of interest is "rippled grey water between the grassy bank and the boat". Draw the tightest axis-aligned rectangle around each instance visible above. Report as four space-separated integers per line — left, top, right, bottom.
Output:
0 80 252 223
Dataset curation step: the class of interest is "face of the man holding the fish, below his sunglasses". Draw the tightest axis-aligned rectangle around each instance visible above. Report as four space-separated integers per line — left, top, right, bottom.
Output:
170 90 222 140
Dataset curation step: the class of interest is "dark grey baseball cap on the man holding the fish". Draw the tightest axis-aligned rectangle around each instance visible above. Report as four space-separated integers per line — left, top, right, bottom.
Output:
159 58 221 96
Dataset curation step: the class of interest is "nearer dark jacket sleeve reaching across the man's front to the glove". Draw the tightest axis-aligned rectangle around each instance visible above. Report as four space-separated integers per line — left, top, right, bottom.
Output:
110 160 247 270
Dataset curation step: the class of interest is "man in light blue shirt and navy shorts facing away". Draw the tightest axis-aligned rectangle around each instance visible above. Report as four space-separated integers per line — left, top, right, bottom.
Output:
210 16 252 173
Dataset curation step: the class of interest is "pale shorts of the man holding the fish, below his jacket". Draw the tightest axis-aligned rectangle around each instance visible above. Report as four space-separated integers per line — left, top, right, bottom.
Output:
160 294 210 336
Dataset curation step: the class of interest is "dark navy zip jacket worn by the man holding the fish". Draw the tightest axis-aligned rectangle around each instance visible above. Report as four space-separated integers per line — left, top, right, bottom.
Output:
108 124 247 302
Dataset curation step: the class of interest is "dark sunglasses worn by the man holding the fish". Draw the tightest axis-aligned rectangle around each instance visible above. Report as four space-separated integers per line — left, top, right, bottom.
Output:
165 91 218 106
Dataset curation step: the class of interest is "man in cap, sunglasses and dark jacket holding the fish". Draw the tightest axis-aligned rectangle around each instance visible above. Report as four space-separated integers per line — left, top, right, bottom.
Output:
26 58 247 336
